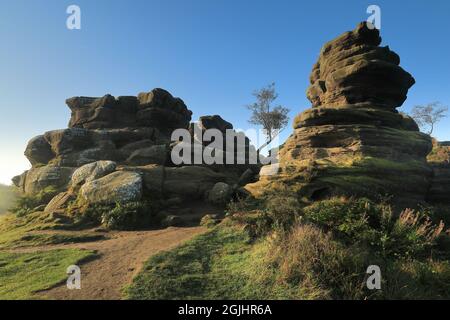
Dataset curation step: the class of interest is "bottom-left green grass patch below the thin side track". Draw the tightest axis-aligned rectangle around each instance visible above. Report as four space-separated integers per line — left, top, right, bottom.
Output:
0 249 94 300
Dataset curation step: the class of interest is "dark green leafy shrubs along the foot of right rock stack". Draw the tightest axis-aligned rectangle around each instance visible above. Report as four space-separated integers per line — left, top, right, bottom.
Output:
303 198 445 257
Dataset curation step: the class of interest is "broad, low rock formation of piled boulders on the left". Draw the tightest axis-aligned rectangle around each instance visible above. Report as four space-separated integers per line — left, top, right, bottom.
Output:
13 89 258 228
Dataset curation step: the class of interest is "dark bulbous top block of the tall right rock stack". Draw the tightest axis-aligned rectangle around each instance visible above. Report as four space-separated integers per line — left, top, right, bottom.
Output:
307 22 415 109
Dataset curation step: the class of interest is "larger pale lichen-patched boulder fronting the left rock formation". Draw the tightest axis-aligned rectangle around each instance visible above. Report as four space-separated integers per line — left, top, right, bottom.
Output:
80 171 142 204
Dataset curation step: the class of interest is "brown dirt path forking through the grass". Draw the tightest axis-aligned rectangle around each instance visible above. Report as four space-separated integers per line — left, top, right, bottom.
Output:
27 227 206 300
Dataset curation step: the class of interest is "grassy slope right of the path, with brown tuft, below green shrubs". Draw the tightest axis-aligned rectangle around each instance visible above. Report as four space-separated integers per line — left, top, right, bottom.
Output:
125 218 450 300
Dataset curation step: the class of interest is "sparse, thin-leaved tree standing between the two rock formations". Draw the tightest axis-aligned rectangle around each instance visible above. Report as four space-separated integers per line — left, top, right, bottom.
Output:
247 83 289 150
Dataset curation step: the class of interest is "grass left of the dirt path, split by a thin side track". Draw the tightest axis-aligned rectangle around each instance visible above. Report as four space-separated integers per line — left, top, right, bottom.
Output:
0 214 102 299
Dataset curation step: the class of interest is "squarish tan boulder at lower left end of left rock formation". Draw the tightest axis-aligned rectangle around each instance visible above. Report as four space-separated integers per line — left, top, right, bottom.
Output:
24 166 75 194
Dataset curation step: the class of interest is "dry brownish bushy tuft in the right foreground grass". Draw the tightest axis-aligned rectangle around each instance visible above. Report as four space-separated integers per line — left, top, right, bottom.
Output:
266 224 373 299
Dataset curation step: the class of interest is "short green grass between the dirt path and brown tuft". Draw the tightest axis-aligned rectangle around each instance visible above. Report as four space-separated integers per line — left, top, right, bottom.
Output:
126 227 270 299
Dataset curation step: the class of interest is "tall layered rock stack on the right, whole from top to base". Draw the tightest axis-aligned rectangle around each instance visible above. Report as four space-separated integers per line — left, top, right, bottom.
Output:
246 22 431 205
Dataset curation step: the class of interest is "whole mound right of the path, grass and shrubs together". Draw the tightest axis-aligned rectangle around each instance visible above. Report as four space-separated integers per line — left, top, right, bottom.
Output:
127 196 450 299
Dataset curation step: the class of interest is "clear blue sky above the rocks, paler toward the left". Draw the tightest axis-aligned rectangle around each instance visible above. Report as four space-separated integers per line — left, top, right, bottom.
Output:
0 0 450 183
